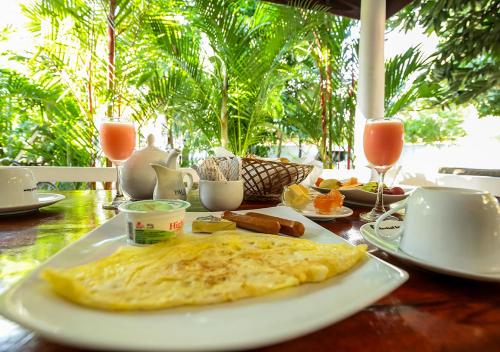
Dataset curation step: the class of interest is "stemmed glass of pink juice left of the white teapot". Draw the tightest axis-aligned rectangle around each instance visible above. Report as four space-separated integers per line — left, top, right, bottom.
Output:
99 118 135 209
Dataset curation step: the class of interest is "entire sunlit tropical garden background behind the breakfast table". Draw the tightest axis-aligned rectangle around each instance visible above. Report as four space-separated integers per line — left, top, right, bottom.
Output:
0 0 500 187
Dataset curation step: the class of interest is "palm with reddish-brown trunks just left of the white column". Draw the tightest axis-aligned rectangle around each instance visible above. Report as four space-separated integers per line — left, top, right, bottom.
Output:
282 12 357 167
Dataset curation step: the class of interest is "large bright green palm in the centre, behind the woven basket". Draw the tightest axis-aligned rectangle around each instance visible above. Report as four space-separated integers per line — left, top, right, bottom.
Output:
145 0 316 155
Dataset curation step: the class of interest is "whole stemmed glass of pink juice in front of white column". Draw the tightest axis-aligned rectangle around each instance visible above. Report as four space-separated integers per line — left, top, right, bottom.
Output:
359 118 404 222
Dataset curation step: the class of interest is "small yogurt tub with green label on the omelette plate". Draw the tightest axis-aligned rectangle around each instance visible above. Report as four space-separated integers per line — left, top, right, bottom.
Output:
118 199 191 245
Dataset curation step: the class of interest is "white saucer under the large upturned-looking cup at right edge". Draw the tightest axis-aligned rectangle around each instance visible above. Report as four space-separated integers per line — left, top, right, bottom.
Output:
360 222 500 282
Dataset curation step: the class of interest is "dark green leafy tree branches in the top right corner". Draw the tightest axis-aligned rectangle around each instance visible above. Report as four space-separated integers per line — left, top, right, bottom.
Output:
398 0 500 115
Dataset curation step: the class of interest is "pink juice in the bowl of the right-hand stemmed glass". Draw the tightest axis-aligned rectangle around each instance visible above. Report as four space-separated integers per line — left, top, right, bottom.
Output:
363 119 403 168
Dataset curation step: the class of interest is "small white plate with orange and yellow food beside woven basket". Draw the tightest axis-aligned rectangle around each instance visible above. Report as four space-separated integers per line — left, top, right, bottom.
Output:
282 185 353 221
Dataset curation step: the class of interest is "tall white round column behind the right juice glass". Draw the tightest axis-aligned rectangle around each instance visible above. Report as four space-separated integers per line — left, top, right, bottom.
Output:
354 0 385 169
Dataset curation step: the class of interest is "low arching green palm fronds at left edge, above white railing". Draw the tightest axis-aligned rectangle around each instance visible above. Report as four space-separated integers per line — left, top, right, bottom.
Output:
0 69 90 166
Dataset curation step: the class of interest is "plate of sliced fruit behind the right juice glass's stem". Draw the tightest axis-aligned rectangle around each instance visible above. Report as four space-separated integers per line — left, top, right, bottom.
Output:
312 177 413 206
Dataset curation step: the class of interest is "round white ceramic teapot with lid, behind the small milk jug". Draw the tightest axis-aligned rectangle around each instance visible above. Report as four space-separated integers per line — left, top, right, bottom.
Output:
121 134 180 199
